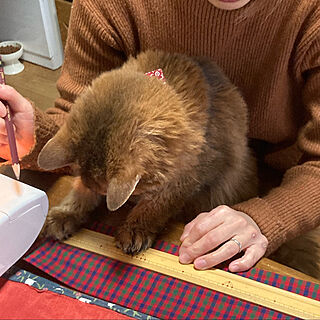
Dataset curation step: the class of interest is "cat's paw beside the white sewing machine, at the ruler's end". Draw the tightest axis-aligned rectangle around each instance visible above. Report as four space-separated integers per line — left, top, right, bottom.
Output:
39 206 80 240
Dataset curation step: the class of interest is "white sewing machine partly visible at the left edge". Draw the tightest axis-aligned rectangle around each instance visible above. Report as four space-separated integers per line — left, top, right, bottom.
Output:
0 174 49 276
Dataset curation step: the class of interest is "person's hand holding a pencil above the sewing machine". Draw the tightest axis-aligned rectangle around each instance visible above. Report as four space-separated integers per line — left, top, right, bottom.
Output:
0 85 34 160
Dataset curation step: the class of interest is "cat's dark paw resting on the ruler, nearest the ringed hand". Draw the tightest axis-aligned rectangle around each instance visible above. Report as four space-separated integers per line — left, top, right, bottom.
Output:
115 225 155 255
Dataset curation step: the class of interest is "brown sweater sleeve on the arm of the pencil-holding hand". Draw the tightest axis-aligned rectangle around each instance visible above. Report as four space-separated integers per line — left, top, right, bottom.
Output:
2 0 125 170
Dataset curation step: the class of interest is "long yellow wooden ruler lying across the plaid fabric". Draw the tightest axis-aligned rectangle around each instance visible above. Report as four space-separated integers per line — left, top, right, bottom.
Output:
64 229 320 319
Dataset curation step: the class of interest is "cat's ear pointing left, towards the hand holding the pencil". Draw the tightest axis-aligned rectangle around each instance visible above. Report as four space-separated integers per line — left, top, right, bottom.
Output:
38 132 74 170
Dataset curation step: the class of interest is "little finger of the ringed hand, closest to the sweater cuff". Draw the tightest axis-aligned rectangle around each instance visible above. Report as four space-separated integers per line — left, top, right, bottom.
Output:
229 241 268 272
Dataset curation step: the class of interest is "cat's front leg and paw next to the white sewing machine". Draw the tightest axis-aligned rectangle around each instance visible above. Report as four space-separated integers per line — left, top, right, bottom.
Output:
40 178 102 240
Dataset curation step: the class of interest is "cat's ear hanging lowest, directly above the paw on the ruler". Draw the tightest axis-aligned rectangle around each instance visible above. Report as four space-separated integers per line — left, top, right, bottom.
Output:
107 175 140 211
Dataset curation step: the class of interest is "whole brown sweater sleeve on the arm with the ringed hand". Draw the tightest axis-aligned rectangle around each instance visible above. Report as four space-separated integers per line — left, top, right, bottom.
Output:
233 26 320 255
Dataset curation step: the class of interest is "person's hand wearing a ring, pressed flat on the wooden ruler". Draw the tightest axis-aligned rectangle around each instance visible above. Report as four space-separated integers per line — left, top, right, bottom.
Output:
179 206 268 272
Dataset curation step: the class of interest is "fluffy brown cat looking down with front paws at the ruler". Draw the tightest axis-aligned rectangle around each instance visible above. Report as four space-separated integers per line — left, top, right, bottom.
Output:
38 51 257 254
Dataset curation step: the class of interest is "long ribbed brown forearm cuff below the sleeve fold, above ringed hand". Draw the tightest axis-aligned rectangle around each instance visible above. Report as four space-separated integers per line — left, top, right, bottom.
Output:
233 161 320 255
